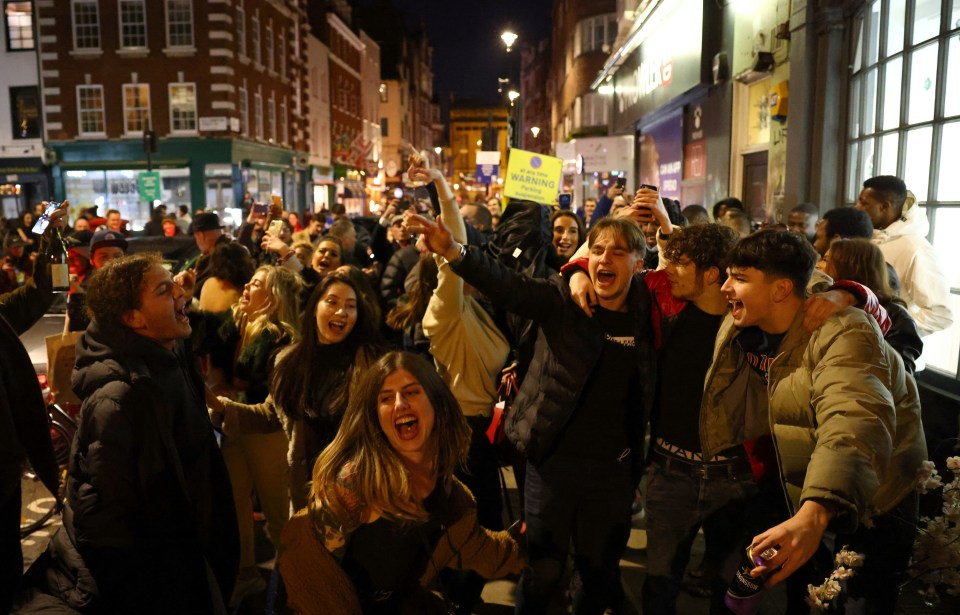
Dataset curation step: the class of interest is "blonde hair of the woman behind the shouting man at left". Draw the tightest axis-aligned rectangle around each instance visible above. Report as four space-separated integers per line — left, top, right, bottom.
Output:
233 265 302 341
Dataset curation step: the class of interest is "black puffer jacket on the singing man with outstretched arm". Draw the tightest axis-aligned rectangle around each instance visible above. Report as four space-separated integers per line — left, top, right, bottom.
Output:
453 247 656 469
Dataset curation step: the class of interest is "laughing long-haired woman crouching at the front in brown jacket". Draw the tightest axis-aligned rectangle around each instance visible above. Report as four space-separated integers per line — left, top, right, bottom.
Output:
278 352 522 613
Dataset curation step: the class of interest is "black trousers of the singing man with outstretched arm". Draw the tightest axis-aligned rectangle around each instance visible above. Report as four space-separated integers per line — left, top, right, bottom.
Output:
516 455 634 614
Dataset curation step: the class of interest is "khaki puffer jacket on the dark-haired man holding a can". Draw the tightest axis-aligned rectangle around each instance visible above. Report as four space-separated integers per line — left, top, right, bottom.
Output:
700 308 926 531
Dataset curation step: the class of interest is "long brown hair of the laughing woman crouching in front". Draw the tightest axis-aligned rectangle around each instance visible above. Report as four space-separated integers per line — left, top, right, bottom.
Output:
309 352 470 521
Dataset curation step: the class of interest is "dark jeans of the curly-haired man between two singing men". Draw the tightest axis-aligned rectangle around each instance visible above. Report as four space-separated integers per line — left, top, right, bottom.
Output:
642 460 757 615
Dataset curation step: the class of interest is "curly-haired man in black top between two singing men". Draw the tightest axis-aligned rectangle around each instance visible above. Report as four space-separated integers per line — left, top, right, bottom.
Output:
642 224 756 613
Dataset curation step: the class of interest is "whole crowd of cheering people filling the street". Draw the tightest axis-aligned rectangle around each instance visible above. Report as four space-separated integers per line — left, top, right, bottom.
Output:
0 165 953 614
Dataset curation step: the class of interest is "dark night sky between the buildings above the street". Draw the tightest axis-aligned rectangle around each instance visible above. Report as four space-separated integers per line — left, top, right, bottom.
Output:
356 0 553 107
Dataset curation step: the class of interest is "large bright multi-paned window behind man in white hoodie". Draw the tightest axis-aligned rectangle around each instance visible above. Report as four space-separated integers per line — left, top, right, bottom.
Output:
844 0 960 379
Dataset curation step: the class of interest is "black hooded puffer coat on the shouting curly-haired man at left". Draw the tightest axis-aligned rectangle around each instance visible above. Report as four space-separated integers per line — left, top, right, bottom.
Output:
50 323 239 613
